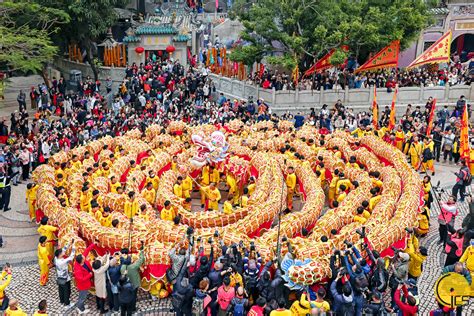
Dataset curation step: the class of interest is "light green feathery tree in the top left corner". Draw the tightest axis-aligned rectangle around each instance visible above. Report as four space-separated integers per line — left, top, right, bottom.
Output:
0 0 69 85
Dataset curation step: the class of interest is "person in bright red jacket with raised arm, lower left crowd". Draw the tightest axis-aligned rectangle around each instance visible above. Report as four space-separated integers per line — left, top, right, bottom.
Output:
73 243 94 315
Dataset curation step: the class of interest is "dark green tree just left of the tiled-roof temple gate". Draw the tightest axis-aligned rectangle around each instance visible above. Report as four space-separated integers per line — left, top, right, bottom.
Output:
36 0 130 80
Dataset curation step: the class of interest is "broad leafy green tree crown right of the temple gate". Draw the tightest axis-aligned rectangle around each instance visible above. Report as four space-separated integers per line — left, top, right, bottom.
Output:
232 0 431 70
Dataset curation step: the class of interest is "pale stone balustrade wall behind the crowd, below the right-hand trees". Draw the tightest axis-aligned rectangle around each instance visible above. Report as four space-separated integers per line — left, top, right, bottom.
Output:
211 75 474 113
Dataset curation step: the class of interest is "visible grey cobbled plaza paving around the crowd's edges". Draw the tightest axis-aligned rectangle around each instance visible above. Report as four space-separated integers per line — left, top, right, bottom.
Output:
0 77 474 315
